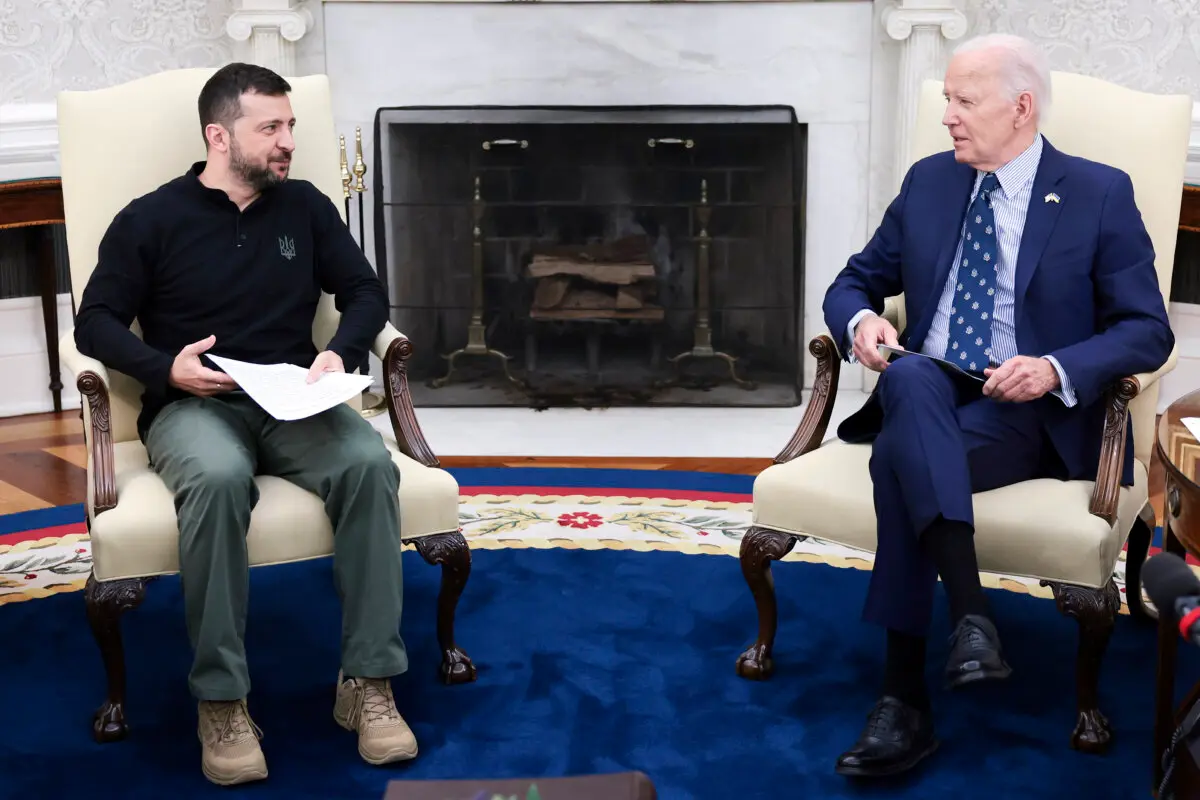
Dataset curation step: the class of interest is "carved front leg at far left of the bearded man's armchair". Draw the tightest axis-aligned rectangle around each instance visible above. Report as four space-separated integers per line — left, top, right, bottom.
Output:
84 573 146 744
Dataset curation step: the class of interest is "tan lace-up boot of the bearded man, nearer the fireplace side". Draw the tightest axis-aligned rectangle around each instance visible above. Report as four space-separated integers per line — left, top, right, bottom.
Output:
334 672 416 764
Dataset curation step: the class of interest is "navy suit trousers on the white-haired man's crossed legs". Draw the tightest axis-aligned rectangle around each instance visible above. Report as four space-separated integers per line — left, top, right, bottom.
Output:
863 356 1057 636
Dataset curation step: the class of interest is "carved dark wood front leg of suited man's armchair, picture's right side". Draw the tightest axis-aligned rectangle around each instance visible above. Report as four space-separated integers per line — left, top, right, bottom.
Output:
1042 578 1121 753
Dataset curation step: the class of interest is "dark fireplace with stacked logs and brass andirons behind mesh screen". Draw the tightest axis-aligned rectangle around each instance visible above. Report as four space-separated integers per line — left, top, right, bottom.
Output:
373 107 806 408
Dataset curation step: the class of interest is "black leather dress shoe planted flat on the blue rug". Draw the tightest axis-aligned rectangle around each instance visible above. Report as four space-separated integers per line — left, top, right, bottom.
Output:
836 694 937 777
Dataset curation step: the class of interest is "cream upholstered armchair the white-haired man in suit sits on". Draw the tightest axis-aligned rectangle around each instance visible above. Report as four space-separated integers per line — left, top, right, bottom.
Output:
737 72 1192 752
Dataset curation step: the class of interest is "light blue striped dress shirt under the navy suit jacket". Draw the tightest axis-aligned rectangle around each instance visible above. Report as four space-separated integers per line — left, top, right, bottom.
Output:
848 133 1076 408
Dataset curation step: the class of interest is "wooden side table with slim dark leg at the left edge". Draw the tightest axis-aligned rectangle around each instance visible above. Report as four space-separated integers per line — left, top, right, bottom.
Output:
0 178 66 411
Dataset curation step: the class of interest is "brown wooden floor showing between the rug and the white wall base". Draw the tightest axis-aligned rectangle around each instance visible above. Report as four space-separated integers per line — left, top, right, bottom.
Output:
0 411 1163 521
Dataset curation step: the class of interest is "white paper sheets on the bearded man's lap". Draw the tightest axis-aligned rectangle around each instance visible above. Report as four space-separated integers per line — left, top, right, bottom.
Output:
205 354 371 420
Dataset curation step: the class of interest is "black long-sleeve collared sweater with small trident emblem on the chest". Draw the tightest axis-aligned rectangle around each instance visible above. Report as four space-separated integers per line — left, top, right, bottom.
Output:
74 162 388 439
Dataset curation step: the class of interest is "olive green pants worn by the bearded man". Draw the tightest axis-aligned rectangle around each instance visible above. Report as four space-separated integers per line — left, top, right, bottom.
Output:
146 392 408 700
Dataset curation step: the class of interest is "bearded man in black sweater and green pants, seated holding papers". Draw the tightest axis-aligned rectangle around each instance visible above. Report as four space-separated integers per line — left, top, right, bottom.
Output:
76 64 416 784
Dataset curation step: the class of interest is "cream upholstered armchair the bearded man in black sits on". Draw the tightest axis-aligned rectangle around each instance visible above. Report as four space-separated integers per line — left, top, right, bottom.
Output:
58 70 475 741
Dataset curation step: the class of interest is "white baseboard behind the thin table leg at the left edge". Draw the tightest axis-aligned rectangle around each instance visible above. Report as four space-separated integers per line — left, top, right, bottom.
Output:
0 294 79 416
